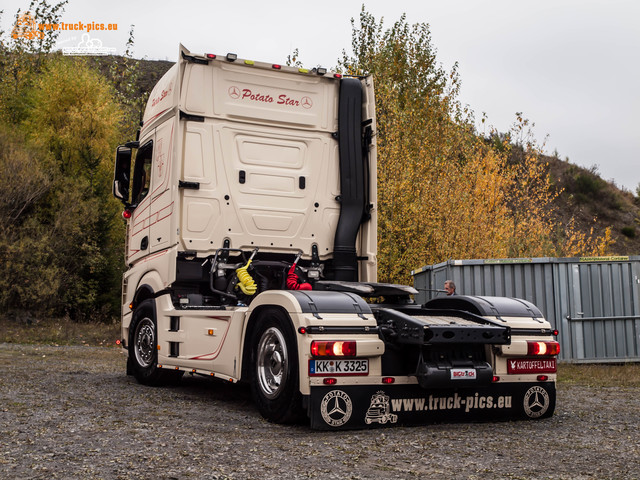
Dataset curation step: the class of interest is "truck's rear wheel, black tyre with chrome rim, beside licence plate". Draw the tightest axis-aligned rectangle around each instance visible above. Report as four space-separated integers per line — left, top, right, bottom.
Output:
251 309 302 423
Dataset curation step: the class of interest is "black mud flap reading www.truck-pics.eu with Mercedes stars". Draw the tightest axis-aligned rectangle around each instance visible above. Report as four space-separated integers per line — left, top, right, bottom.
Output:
309 382 556 430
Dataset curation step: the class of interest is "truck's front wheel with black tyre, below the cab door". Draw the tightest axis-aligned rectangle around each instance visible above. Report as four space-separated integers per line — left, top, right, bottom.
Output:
127 299 183 385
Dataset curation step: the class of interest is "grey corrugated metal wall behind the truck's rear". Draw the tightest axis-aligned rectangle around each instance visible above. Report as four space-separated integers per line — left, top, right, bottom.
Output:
412 256 640 362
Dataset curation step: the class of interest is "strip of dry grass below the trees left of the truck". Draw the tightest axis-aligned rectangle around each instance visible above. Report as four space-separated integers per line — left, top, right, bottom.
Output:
0 316 120 346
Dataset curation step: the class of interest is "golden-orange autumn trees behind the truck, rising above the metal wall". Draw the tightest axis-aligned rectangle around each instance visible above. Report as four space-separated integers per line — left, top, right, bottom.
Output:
340 9 611 283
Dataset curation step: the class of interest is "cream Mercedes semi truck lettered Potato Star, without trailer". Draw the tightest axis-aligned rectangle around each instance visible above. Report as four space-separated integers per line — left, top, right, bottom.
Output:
113 46 559 429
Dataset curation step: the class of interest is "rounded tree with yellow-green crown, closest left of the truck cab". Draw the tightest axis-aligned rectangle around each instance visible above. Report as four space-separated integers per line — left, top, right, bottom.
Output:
22 57 123 312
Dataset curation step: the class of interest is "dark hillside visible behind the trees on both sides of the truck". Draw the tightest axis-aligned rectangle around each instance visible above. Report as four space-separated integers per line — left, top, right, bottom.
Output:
112 57 640 255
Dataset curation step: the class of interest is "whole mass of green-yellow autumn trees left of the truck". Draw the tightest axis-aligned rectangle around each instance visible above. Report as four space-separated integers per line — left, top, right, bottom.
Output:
0 1 131 319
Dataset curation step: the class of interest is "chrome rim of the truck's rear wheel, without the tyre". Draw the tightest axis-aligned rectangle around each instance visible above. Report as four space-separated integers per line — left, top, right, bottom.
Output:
256 327 288 399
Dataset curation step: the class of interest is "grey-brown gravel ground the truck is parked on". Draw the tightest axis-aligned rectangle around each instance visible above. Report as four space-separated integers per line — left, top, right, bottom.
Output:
0 344 640 480
